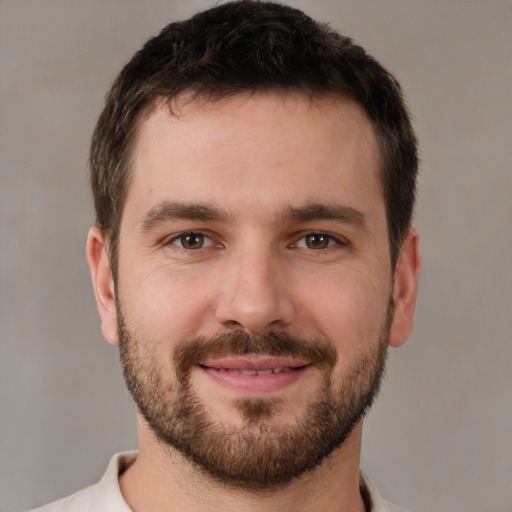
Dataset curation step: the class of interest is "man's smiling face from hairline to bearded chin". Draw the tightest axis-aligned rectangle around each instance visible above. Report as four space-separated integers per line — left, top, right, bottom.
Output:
86 94 418 488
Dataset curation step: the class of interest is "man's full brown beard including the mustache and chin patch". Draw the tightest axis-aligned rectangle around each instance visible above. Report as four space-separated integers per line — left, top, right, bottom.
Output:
117 301 392 491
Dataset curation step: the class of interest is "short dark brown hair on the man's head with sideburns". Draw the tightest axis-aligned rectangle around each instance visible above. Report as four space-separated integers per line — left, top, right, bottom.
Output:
90 0 418 273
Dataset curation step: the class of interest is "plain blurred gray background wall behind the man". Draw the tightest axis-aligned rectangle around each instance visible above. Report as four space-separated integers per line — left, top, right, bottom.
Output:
0 0 512 512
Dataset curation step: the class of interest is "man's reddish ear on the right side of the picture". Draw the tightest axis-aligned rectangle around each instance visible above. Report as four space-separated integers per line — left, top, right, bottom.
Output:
389 228 421 347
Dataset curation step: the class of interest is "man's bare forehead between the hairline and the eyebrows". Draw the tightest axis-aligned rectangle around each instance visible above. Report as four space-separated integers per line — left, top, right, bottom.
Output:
127 93 383 226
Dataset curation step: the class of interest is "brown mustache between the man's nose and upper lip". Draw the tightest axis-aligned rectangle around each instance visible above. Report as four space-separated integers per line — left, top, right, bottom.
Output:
174 331 338 382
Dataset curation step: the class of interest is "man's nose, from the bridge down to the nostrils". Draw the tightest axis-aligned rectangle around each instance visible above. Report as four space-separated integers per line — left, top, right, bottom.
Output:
215 245 296 335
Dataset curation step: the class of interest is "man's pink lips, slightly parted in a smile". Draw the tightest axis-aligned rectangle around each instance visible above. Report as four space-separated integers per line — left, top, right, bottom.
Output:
198 356 311 395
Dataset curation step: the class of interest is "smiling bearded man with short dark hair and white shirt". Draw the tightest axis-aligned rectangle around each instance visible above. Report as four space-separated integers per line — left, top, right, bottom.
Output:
34 1 420 512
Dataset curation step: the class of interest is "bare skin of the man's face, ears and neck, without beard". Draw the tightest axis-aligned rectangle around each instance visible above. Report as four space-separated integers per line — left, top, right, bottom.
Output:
87 94 420 512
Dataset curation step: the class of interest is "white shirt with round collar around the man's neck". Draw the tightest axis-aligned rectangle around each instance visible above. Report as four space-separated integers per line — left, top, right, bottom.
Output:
30 452 405 512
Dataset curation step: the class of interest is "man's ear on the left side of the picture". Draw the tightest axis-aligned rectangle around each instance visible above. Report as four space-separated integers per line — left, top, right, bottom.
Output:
86 226 118 345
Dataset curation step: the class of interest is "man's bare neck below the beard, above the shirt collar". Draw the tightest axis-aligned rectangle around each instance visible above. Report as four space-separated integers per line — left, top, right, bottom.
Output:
119 421 365 512
